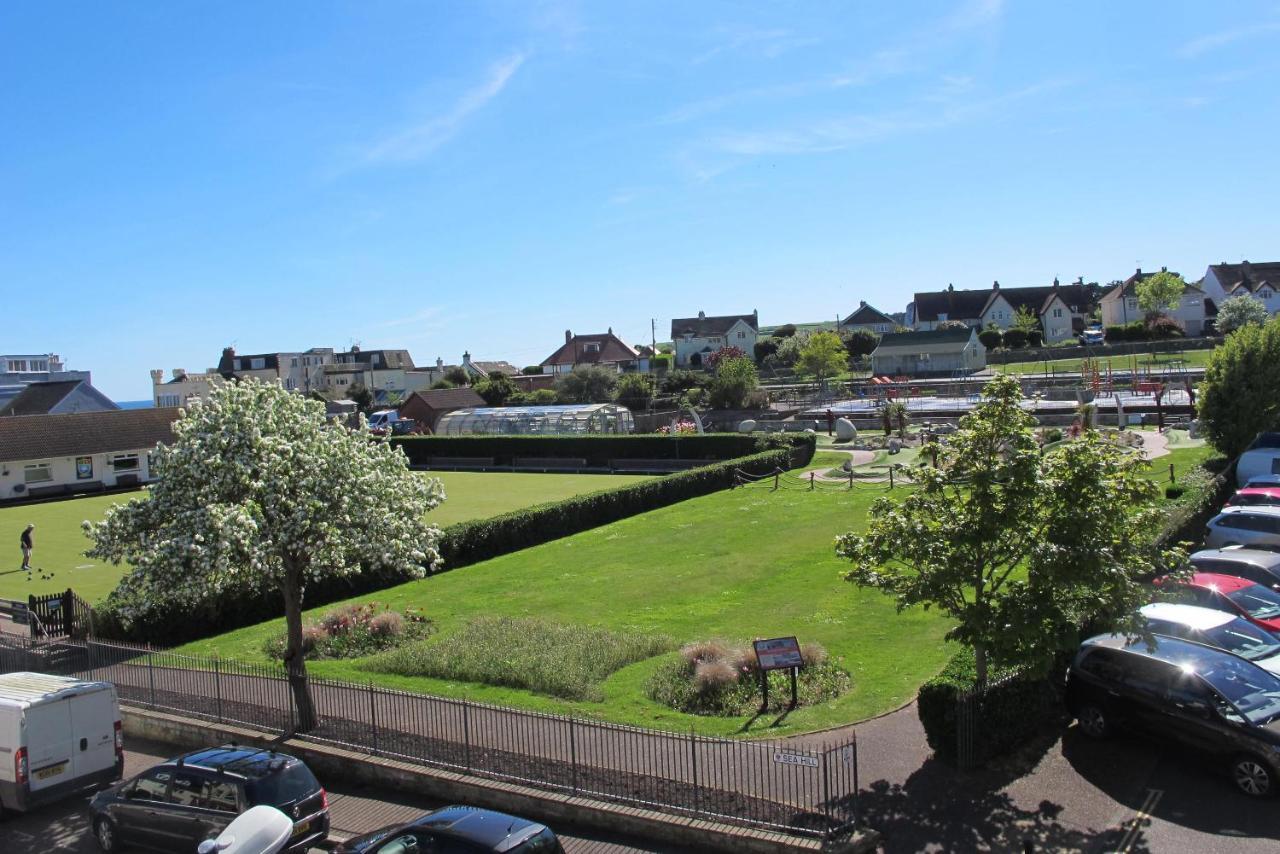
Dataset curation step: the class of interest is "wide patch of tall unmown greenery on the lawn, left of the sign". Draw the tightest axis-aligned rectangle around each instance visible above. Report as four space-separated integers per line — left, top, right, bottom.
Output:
361 617 676 700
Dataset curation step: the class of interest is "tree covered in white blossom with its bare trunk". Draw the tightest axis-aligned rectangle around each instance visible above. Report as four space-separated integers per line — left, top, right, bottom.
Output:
84 380 444 731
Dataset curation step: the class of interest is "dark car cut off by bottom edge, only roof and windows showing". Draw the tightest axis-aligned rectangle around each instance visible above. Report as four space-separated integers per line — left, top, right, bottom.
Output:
334 807 564 854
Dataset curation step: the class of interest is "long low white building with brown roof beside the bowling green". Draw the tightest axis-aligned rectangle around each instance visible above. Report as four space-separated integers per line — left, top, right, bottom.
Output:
0 408 178 501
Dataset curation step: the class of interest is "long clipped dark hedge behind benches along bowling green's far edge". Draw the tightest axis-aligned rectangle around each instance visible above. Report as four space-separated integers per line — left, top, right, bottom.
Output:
392 433 759 467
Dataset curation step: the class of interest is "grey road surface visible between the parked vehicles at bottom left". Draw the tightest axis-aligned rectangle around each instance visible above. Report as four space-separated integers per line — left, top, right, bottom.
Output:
0 741 671 854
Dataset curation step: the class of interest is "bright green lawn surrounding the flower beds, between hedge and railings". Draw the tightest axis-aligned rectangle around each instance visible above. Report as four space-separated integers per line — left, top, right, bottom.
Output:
183 485 951 734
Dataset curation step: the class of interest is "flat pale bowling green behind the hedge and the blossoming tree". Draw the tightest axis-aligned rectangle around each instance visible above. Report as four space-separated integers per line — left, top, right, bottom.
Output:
0 471 645 602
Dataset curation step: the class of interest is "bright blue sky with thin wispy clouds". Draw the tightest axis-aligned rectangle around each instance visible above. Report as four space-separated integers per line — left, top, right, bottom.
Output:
0 0 1280 399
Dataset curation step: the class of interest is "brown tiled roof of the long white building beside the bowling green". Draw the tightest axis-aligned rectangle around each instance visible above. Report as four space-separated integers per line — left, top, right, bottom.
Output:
0 408 178 462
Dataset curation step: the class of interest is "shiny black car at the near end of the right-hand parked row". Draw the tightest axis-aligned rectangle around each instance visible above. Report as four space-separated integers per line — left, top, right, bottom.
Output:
1066 635 1280 796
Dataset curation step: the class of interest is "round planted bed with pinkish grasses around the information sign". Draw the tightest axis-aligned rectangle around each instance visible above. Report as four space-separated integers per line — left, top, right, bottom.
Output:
645 640 852 717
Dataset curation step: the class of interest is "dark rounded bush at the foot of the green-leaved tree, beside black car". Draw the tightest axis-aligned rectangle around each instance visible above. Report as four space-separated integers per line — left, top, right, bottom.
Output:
916 649 1064 764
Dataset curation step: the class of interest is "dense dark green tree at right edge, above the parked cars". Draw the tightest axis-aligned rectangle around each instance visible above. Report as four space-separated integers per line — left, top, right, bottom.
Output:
1197 318 1280 457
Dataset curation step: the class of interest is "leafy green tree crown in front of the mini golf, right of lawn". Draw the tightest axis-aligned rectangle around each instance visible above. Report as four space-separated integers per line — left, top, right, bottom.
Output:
836 376 1171 682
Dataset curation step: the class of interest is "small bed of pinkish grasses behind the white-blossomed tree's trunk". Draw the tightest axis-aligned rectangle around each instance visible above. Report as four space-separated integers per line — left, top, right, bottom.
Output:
264 602 434 659
